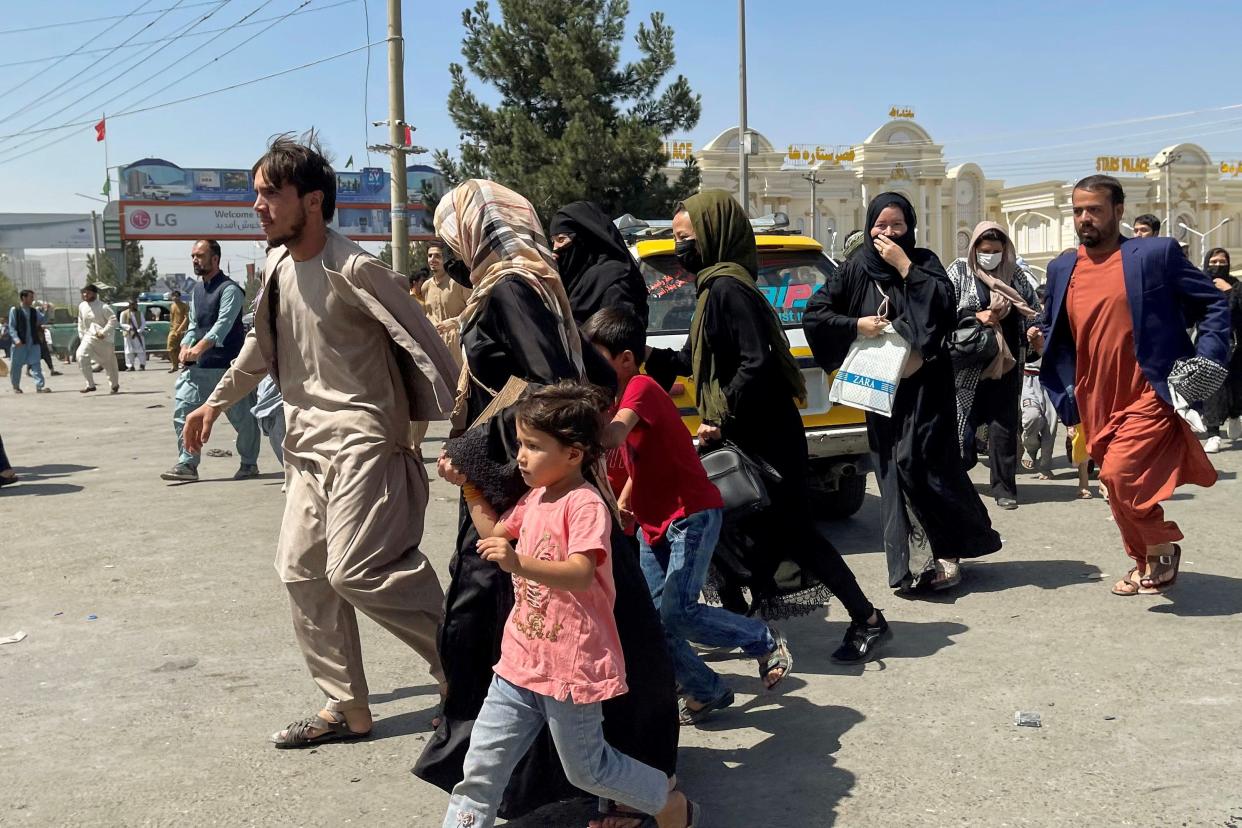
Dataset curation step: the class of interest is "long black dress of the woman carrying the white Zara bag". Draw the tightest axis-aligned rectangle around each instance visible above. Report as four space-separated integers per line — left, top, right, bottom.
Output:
802 248 1001 587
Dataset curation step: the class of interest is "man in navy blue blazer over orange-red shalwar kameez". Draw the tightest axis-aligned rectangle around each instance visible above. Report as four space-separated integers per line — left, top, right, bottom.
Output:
1031 175 1230 596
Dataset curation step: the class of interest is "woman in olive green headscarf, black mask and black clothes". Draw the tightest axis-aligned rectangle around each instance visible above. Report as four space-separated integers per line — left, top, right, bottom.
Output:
646 190 888 669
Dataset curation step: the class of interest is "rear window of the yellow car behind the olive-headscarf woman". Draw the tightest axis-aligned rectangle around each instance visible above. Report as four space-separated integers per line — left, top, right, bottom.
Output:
638 248 837 334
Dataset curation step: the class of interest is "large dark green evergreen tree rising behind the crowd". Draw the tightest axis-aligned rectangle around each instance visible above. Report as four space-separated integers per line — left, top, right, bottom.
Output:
436 0 700 221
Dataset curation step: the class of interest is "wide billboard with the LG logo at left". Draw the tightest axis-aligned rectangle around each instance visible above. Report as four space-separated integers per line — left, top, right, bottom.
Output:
118 158 445 241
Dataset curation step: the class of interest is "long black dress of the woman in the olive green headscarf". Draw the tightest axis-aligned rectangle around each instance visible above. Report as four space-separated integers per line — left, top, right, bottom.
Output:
646 278 874 622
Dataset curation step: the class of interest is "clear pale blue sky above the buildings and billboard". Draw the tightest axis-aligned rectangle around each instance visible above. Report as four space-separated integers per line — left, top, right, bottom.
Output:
0 0 1242 276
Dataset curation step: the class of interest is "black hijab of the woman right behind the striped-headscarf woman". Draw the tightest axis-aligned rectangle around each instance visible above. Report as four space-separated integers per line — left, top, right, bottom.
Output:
548 201 647 325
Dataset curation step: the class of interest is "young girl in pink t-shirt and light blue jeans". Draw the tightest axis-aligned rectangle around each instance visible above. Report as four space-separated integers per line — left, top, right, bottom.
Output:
443 382 699 828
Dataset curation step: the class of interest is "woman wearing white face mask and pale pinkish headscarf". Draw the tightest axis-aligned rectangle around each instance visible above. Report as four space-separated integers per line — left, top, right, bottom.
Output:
949 221 1040 509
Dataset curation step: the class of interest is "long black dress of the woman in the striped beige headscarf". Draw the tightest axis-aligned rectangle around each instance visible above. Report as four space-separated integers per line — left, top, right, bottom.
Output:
414 279 678 819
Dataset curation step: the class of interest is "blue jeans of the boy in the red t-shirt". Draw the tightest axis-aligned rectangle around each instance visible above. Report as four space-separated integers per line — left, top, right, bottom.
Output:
638 509 776 701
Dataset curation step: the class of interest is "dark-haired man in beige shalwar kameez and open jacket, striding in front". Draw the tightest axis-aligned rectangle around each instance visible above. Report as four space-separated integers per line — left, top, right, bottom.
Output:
184 138 455 747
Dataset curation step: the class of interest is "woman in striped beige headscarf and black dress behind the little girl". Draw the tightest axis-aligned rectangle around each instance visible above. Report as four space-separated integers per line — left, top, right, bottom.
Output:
414 179 678 819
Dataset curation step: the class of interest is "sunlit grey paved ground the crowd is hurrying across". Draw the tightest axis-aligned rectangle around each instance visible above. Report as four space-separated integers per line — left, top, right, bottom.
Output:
0 364 1242 828
